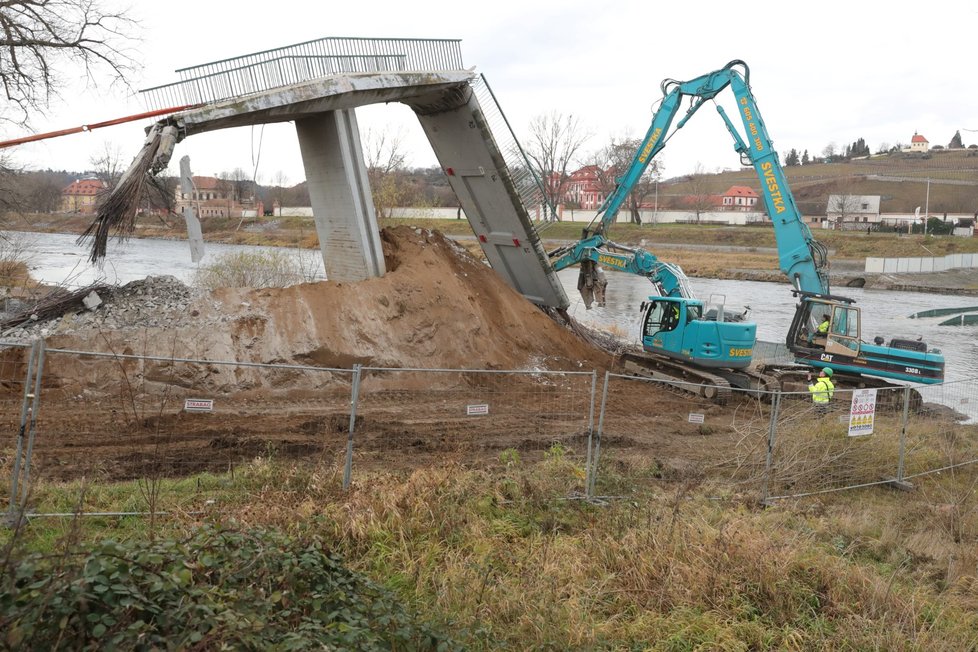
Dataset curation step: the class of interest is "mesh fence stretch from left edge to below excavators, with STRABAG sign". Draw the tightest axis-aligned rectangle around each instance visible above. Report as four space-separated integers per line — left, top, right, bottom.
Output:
0 342 596 519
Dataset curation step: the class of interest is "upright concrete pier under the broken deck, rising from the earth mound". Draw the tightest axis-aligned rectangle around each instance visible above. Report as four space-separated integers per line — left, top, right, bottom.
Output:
295 109 386 282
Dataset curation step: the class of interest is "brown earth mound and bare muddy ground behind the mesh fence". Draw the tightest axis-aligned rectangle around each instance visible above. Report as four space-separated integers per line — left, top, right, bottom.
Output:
0 227 968 488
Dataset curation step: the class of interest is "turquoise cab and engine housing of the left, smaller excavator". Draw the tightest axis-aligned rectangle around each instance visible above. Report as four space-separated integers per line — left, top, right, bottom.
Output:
640 297 757 369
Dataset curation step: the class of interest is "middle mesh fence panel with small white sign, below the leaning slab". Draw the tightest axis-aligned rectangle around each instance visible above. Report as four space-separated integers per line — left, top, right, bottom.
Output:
352 368 595 491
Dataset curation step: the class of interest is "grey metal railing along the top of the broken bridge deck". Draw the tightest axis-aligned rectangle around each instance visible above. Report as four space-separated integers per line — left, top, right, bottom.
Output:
140 37 464 109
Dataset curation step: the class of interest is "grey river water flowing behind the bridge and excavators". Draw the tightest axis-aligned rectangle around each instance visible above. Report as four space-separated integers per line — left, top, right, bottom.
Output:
2 233 978 380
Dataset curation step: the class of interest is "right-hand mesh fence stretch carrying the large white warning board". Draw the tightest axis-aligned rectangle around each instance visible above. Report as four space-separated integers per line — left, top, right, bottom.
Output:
590 374 978 502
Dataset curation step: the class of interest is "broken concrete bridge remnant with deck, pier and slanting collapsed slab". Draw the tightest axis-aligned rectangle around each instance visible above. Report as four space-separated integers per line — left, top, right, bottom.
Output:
137 39 569 308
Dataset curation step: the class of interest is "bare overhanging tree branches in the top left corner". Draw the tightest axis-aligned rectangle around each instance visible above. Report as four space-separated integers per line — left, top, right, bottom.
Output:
0 0 138 126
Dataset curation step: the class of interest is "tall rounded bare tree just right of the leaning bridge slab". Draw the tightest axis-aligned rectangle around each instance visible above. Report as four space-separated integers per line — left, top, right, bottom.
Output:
526 111 591 218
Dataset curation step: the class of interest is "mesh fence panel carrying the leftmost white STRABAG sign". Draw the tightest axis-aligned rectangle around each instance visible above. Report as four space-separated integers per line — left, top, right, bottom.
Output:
0 349 353 513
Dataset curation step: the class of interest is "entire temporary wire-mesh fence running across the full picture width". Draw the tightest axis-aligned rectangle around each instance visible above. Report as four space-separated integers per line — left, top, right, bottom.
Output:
0 342 978 518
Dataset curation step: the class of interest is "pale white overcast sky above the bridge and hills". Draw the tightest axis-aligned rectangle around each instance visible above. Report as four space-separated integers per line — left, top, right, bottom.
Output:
7 0 978 183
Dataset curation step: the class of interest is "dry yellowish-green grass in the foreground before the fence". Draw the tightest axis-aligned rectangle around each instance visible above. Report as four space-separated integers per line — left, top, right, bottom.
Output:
7 450 978 650
